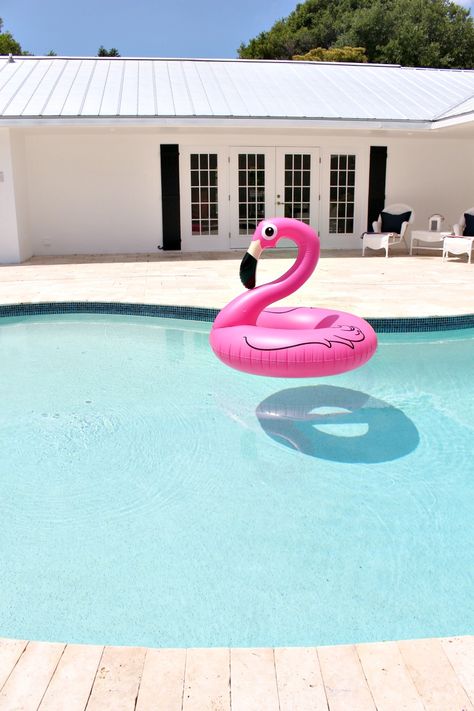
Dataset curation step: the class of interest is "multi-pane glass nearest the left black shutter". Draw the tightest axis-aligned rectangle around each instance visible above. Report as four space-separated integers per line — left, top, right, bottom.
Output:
190 153 218 235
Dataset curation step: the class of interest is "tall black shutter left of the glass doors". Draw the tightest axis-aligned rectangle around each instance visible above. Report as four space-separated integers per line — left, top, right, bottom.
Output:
161 144 181 249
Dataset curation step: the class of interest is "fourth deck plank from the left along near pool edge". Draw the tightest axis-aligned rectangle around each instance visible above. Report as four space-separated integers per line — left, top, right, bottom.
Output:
87 647 146 711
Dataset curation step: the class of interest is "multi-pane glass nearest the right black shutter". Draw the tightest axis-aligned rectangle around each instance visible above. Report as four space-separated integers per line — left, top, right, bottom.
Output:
329 154 356 234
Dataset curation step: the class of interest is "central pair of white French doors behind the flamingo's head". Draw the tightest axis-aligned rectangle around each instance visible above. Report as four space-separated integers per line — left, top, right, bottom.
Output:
229 147 319 248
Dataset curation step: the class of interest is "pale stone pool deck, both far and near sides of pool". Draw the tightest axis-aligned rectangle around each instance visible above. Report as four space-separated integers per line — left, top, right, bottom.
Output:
0 252 474 711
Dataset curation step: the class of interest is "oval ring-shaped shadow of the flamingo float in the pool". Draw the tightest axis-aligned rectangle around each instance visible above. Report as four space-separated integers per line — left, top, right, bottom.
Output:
255 385 420 464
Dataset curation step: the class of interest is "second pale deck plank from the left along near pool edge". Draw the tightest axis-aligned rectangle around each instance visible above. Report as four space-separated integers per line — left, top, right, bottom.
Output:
0 642 65 711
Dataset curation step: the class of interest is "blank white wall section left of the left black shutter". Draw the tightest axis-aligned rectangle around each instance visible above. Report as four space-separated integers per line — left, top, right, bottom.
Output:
25 129 162 255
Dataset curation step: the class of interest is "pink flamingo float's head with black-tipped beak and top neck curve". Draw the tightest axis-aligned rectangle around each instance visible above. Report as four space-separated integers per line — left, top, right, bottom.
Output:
240 217 319 289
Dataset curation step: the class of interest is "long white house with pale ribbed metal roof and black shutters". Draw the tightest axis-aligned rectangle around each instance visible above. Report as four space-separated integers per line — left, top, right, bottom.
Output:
0 57 474 263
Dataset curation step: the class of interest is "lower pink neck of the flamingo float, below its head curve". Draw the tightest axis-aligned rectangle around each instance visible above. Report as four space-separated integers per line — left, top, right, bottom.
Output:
214 240 319 328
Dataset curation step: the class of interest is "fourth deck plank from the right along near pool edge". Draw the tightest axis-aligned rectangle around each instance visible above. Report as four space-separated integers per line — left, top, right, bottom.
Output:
318 646 376 711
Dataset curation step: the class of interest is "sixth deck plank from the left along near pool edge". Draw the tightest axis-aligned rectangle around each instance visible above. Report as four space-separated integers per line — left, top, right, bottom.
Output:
183 649 230 711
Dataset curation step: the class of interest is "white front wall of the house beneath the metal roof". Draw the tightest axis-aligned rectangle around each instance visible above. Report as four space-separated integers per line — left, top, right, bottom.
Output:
0 127 474 262
